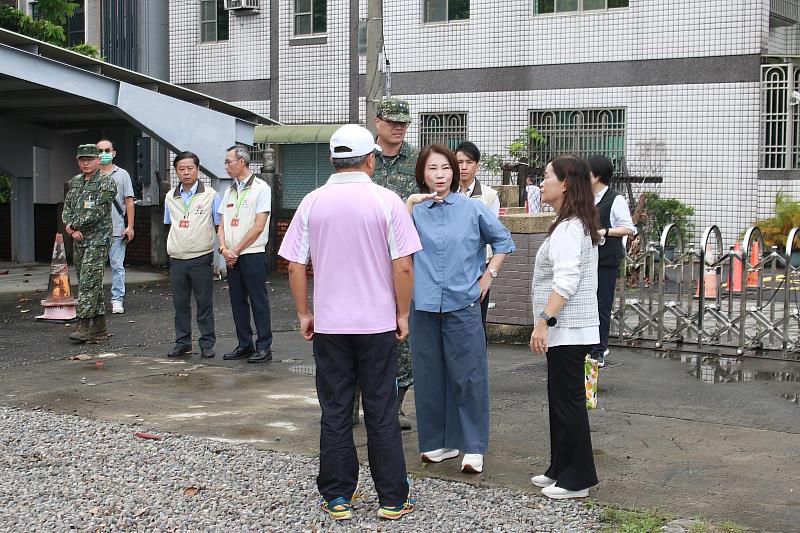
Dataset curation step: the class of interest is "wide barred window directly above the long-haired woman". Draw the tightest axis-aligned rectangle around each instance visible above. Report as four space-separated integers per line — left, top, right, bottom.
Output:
530 109 625 169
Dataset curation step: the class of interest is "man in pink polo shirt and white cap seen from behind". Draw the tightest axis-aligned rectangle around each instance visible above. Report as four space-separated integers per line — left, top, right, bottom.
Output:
278 124 422 520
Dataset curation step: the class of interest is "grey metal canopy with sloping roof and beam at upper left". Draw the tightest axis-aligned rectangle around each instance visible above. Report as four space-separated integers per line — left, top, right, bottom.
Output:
0 29 277 179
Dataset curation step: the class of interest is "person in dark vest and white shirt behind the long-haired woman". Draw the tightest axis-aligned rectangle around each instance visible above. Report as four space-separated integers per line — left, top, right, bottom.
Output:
589 155 636 366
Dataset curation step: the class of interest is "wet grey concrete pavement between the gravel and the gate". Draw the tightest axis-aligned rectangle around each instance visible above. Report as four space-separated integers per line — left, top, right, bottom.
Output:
0 268 800 531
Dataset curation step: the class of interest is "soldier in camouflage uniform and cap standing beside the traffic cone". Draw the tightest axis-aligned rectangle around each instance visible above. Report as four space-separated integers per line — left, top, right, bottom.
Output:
62 144 117 342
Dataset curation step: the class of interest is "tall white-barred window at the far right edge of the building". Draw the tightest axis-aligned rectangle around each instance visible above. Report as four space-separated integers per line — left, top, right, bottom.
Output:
759 64 800 170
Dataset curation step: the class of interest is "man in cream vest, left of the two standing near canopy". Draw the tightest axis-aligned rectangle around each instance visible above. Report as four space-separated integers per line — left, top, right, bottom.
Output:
164 152 220 358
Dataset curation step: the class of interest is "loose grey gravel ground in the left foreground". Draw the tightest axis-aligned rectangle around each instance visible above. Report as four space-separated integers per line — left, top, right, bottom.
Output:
0 407 599 532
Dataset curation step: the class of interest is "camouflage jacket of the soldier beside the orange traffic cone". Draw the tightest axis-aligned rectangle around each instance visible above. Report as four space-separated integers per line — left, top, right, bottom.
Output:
62 170 117 244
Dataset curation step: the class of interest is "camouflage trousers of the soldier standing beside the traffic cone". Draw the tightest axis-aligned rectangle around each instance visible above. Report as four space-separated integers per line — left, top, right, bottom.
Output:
72 241 109 318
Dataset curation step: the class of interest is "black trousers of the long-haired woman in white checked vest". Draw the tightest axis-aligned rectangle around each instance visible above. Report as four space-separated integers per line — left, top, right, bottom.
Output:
545 346 597 490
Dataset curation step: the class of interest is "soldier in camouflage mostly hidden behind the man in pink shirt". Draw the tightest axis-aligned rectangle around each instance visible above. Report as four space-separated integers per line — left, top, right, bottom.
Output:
372 98 419 429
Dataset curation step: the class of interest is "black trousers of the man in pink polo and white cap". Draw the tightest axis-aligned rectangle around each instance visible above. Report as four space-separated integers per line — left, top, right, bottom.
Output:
314 331 408 506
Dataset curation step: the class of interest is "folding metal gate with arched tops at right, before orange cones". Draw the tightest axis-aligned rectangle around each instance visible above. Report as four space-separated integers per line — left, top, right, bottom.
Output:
612 224 800 359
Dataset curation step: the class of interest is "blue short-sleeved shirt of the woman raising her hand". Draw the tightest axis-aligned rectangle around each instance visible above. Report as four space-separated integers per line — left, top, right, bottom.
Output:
412 192 516 313
